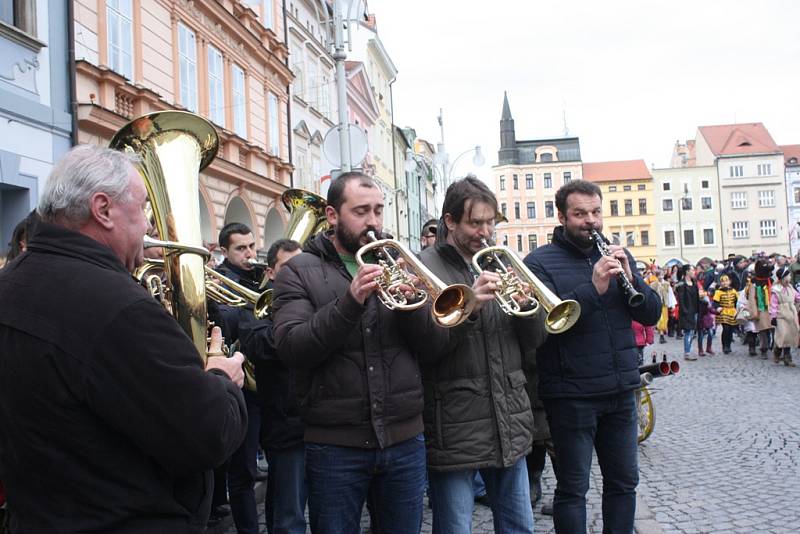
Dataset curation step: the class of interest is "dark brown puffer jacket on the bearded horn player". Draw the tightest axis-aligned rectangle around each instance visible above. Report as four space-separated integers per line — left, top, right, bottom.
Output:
274 234 447 448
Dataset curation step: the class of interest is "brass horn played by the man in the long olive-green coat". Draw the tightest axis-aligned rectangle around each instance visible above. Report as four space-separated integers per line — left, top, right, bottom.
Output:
472 239 581 334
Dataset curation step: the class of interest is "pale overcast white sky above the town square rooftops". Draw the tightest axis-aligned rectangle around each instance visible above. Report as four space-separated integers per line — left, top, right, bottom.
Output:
369 0 800 179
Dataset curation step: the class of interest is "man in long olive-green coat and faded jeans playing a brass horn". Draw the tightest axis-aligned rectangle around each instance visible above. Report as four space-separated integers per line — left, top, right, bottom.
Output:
421 176 544 534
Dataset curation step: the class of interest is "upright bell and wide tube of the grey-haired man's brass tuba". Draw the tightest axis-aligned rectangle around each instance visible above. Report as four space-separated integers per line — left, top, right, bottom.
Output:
109 111 219 361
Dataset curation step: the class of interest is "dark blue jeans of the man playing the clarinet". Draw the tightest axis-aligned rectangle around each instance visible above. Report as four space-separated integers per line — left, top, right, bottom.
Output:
544 391 639 534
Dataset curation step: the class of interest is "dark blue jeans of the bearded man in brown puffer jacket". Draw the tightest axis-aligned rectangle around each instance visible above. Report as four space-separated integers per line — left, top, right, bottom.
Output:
306 434 424 534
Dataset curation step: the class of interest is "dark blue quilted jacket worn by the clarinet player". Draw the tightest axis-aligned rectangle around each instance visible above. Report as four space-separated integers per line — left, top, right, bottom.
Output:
525 226 661 398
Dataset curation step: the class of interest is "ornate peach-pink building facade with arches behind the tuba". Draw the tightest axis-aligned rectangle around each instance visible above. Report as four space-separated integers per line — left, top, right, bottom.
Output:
74 0 293 249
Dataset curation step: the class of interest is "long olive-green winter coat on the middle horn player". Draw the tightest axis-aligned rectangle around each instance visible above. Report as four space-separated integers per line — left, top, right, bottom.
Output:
420 243 545 471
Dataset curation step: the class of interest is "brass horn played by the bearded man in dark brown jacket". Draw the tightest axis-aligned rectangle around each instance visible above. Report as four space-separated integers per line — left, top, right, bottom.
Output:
356 231 477 328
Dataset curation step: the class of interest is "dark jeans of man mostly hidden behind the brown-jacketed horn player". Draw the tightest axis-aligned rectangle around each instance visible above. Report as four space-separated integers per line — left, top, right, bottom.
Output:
264 443 308 534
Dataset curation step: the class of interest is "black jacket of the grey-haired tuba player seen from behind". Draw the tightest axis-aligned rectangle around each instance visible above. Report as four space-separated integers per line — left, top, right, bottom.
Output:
0 223 247 533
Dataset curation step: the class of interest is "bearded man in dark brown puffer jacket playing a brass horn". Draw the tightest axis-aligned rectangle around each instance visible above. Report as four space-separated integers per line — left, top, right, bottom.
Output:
274 172 447 534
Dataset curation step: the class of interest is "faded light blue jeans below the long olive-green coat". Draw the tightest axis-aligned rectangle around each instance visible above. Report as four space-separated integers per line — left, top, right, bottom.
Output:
430 457 533 534
